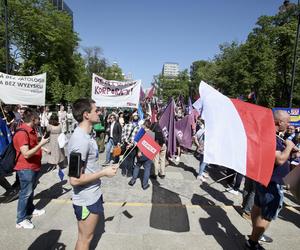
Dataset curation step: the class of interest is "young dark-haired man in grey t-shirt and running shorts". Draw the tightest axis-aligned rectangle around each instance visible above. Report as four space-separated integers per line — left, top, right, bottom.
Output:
68 98 118 250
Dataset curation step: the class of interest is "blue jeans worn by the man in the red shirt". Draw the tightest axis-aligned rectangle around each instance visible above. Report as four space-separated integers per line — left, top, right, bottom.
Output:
17 169 39 223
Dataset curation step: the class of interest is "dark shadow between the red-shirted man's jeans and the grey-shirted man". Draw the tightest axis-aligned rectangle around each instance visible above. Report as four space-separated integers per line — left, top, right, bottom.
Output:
34 180 71 209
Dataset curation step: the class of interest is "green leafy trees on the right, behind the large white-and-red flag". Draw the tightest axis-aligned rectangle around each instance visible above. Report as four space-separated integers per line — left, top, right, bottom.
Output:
191 7 300 107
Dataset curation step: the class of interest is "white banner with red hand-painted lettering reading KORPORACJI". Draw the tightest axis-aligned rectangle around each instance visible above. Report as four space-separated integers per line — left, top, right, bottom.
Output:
92 74 141 108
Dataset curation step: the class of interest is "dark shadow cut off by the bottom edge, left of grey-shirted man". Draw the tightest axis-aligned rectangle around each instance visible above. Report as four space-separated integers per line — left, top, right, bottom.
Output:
28 230 66 250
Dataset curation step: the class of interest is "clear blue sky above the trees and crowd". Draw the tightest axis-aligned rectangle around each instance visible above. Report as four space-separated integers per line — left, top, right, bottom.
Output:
65 0 288 88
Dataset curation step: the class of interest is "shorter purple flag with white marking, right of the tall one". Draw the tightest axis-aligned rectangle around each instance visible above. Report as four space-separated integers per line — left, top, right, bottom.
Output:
175 114 194 149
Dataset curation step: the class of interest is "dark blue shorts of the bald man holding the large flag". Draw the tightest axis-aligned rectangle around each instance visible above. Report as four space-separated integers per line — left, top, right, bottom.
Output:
254 182 283 221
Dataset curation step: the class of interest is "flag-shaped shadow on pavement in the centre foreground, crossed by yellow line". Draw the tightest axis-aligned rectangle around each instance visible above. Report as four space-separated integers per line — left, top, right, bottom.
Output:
150 180 190 232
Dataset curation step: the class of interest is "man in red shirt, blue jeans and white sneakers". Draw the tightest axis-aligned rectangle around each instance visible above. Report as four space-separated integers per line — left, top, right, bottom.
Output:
13 109 49 229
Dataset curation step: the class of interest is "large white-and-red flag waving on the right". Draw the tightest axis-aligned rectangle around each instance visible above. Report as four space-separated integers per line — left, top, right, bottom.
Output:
199 81 276 186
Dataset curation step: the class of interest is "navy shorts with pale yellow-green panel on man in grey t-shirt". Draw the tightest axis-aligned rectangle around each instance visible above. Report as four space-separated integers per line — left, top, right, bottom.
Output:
73 195 104 221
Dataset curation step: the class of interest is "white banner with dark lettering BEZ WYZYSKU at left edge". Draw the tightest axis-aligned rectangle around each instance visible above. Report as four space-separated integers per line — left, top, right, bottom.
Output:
0 72 46 105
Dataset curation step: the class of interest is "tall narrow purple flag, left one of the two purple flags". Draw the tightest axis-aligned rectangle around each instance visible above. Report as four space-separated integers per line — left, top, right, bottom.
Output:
159 98 176 156
